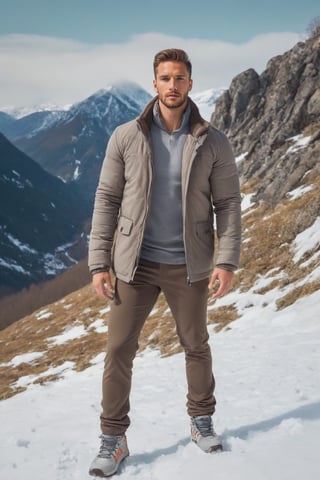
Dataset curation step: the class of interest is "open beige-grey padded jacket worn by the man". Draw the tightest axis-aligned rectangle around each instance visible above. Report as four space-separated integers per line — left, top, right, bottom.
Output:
89 97 241 282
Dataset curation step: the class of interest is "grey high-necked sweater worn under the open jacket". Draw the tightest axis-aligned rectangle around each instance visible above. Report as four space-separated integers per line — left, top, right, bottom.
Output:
141 103 190 265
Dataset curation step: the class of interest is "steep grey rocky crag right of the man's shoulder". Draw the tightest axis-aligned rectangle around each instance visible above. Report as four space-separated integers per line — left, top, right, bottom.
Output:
211 35 320 206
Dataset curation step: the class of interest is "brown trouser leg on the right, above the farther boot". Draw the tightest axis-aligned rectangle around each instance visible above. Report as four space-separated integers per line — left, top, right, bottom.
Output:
161 266 216 416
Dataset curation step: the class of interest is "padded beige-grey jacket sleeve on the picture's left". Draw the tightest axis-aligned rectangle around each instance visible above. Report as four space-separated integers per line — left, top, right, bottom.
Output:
88 129 125 272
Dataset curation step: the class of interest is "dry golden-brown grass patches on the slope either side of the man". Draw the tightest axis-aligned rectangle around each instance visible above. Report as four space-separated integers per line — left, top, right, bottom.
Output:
0 167 320 399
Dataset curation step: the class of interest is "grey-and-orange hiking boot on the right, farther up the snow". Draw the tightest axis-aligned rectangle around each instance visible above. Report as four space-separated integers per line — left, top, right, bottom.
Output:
191 415 223 453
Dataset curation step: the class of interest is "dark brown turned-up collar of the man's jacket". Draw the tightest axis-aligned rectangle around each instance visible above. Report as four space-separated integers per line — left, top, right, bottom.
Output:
137 95 210 137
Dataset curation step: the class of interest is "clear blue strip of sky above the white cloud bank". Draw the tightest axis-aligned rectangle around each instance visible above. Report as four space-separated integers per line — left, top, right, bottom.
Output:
0 0 320 43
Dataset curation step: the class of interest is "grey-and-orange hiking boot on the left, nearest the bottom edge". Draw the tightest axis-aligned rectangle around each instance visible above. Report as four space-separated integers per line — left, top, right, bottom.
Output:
89 434 129 477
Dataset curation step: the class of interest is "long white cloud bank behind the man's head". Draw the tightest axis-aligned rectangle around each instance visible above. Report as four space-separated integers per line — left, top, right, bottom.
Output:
0 32 301 108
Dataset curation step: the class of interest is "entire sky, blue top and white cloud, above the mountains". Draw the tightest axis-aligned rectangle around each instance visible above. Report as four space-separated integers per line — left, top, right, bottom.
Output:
0 0 320 108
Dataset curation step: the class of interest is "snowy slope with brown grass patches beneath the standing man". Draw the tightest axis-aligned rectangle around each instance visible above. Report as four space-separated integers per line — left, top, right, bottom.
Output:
0 178 320 480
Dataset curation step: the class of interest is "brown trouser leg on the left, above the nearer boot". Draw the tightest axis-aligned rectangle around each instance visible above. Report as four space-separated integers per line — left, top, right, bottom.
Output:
101 267 160 435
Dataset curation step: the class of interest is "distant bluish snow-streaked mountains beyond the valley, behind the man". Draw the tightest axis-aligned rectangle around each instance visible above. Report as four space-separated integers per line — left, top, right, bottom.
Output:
0 83 226 297
